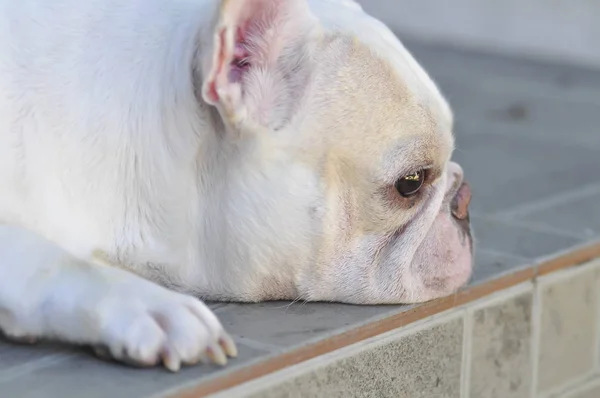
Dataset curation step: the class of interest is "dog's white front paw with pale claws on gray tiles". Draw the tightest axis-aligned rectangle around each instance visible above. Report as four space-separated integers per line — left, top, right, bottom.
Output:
94 286 237 372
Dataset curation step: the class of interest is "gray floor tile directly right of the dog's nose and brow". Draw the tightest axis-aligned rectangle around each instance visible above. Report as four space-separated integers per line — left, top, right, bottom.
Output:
454 130 600 215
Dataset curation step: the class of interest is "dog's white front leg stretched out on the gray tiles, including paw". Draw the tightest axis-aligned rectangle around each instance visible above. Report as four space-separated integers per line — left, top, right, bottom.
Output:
0 226 236 371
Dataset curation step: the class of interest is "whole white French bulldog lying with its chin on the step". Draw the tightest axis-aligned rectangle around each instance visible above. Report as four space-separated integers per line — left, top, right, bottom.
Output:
0 0 473 371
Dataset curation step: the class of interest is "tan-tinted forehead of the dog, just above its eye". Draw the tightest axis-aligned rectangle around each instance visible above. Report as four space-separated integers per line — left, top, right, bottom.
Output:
308 31 454 179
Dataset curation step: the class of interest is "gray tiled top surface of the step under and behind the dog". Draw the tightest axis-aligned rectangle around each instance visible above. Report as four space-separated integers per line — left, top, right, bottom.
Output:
0 39 600 398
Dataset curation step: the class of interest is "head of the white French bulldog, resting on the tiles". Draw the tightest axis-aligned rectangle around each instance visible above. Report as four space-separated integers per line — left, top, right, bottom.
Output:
200 0 473 304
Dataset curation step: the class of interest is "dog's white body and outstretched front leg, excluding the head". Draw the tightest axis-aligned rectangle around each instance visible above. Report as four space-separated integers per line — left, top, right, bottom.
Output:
0 0 240 368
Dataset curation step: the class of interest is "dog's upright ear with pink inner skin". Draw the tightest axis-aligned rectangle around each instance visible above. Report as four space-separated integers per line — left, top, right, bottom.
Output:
202 0 315 134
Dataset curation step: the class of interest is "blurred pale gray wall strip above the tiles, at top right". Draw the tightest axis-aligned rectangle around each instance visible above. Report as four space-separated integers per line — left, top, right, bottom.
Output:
358 0 600 68
